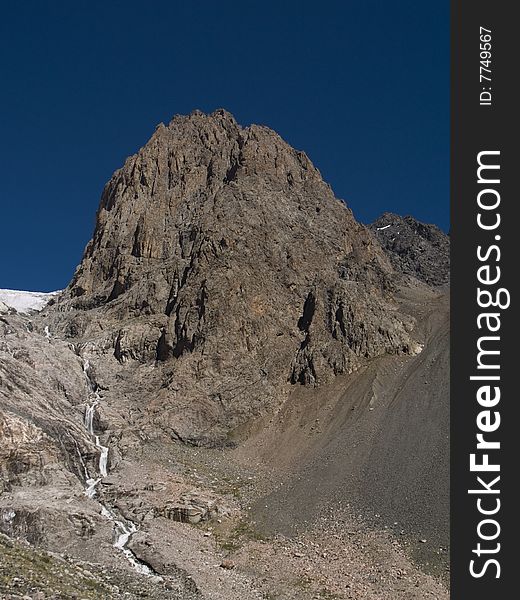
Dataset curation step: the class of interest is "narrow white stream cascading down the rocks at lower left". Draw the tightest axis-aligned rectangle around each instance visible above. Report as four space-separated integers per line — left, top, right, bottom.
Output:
77 359 155 576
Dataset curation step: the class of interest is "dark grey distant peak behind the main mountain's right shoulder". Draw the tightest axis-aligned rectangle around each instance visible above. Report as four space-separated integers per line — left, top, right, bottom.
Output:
370 213 450 286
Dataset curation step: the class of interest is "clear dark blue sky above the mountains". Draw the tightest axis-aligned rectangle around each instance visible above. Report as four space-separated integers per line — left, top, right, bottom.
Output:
0 0 449 290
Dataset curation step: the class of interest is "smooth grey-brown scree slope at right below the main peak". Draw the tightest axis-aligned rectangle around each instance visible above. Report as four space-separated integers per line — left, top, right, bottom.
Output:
245 286 449 575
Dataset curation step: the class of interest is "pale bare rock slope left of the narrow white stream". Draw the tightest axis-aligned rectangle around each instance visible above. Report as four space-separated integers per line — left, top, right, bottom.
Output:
0 315 95 492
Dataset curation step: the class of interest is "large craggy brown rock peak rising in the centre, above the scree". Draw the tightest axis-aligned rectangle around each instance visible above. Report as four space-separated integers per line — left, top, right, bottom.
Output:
51 110 415 439
